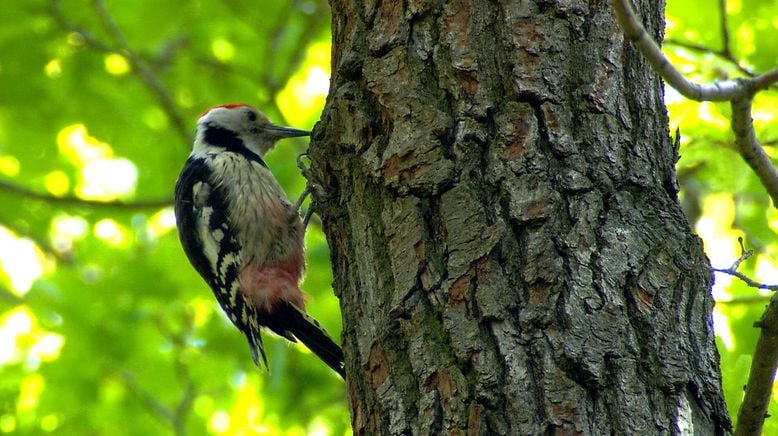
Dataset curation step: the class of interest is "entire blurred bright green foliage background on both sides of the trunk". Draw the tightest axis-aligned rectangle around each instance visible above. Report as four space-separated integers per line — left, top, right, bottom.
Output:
0 0 778 435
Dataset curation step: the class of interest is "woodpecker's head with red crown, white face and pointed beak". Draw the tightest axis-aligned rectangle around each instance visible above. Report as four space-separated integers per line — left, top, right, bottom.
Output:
192 103 310 157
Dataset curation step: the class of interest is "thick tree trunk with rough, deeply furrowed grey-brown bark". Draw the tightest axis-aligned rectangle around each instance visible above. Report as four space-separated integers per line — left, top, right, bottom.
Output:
311 0 730 435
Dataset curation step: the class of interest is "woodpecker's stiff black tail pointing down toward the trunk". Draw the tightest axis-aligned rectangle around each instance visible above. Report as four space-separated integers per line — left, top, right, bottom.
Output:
266 302 346 379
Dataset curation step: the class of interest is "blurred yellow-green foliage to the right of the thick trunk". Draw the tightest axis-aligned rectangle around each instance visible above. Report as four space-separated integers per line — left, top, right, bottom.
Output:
664 0 778 434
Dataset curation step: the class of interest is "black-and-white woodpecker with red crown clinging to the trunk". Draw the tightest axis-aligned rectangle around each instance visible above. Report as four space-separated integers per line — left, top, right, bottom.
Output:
175 103 345 377
